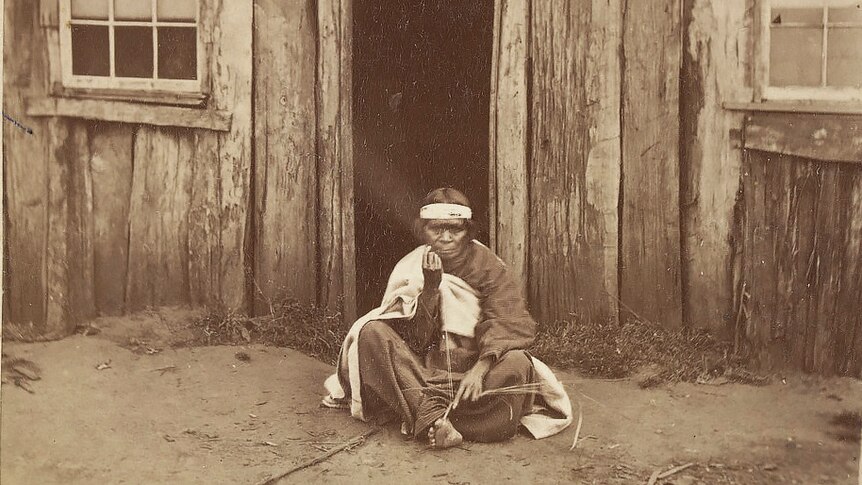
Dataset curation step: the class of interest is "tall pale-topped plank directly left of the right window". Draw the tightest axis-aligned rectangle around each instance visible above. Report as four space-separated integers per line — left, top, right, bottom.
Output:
680 0 752 335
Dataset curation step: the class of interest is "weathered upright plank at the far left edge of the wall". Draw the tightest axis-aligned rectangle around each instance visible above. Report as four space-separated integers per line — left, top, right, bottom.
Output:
3 2 49 333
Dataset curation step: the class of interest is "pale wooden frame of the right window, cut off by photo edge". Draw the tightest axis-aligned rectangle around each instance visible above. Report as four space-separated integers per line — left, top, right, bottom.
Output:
753 0 862 105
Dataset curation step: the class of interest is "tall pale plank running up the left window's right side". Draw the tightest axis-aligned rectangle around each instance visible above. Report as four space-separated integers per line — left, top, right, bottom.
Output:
210 0 254 310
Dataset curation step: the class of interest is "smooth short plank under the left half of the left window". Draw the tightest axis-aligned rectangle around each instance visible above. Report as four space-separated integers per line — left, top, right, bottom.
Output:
90 123 134 315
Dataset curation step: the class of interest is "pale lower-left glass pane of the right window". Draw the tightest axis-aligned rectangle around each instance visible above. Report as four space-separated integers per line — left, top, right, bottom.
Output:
769 27 823 86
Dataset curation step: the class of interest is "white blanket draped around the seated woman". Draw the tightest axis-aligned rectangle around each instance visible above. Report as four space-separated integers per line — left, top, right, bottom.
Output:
323 246 572 439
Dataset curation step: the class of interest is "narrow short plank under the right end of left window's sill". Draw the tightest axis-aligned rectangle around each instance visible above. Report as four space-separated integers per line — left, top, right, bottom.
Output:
188 131 221 306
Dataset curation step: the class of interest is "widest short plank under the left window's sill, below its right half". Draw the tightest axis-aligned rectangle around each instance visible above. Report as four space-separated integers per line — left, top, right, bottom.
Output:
125 126 193 311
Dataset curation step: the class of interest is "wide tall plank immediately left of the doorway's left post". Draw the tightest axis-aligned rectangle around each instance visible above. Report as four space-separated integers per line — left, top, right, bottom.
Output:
254 0 317 314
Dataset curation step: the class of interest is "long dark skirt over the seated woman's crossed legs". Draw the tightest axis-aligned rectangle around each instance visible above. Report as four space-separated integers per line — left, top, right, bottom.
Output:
359 321 533 442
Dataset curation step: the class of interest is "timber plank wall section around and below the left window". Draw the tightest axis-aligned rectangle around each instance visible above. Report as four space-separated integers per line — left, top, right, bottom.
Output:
4 1 252 332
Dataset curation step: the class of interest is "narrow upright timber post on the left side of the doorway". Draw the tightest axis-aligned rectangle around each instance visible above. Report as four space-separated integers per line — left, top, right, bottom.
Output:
316 0 356 320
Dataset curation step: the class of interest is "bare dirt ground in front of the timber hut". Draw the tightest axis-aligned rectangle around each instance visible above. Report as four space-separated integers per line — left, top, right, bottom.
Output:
0 309 862 485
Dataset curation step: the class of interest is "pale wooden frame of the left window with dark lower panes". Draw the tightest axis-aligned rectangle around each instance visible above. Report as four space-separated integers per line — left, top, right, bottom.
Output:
57 0 210 106
